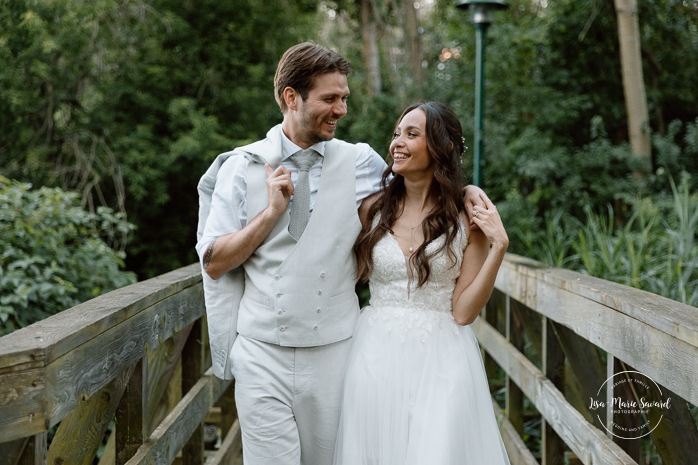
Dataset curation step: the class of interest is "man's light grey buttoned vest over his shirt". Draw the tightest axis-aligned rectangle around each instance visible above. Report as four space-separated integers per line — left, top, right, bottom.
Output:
237 140 361 347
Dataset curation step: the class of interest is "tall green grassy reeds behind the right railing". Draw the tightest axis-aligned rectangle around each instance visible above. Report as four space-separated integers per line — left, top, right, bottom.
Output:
528 176 698 306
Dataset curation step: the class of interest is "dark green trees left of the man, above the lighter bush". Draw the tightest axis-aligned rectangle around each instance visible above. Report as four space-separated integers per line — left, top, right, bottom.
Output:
0 0 317 277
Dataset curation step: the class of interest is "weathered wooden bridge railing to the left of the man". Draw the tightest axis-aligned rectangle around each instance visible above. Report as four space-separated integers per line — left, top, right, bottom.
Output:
0 265 240 465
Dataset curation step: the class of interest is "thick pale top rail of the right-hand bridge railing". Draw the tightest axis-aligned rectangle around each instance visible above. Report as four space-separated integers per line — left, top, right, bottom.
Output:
497 254 698 405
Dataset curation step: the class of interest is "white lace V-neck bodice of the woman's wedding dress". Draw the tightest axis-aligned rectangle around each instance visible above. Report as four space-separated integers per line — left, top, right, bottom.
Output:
368 219 467 336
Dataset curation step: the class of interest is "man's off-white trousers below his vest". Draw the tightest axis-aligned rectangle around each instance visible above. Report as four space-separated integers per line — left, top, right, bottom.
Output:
232 335 351 465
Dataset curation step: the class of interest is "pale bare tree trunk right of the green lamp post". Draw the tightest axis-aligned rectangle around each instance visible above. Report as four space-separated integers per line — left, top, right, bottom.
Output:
614 0 652 176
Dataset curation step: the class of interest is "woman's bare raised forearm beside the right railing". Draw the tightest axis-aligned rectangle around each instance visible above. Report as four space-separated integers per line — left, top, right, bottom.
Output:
453 244 507 325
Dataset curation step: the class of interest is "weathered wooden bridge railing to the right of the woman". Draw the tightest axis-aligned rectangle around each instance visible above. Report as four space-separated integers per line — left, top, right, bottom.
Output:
484 254 698 464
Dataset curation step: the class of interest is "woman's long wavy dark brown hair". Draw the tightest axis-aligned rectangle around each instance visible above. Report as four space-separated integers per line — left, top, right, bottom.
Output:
354 102 465 287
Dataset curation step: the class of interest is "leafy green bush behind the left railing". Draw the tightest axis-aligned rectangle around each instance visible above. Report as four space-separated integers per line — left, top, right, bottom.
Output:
0 176 135 335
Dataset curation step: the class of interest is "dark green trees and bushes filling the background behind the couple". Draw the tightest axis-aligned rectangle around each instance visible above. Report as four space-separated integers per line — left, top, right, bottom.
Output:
0 0 698 331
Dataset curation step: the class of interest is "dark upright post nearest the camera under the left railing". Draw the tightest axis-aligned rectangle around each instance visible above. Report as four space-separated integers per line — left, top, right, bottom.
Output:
114 359 146 465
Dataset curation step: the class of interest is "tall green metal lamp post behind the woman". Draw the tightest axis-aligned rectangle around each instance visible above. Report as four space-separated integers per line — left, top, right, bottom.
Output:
456 0 502 186
